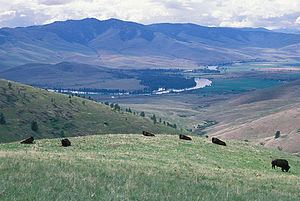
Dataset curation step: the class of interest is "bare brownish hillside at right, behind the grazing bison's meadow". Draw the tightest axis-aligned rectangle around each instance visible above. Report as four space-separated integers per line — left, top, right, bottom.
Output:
208 81 300 153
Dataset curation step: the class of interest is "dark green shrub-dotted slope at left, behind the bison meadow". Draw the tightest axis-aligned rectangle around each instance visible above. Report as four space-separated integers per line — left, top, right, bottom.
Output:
0 80 178 142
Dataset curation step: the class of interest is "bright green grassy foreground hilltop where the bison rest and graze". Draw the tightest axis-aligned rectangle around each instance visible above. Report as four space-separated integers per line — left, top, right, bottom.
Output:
0 134 300 201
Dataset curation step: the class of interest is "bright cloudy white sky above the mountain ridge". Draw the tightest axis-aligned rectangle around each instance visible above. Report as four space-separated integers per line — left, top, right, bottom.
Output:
0 0 300 29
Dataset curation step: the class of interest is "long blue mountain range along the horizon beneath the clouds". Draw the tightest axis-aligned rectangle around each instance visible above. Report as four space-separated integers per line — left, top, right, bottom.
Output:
0 18 300 70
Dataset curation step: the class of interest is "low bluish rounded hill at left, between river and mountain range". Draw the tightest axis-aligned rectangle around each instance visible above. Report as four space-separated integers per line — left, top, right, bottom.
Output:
0 62 143 90
